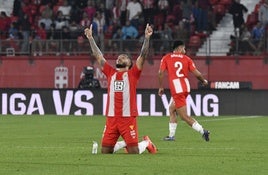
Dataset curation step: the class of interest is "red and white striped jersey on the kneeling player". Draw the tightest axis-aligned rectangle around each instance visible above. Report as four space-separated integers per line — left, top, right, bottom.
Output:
102 62 141 117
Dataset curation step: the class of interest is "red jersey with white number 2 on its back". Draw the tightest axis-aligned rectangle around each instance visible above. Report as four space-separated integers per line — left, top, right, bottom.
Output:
160 53 196 95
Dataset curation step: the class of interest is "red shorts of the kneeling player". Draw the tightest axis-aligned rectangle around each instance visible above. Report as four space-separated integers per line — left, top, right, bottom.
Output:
102 117 139 147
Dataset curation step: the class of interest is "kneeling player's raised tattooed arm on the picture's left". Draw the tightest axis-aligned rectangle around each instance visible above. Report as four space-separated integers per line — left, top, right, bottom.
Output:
84 24 106 67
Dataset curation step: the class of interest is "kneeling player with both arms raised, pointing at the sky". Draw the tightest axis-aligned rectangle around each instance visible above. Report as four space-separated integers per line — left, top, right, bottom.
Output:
84 24 157 154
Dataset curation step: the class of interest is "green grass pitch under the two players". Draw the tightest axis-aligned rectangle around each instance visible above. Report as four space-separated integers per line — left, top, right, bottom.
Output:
0 115 268 175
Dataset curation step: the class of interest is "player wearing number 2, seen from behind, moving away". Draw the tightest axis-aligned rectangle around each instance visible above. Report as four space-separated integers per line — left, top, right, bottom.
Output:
158 41 210 141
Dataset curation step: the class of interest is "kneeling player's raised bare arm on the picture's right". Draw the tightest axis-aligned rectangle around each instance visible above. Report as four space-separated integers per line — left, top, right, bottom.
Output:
136 24 153 70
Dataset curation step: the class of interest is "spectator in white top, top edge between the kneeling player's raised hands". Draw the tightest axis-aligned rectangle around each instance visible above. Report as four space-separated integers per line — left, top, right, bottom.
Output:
127 0 142 30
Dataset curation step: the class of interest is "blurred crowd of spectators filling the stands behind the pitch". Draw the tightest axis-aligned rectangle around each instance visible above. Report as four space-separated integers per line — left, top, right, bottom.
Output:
0 0 268 55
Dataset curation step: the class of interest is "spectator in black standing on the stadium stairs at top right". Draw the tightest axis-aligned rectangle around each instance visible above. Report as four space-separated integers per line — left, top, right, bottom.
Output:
229 0 248 36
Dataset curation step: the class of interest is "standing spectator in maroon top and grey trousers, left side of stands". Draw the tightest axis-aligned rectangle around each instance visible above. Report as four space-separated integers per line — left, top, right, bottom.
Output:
32 22 47 56
